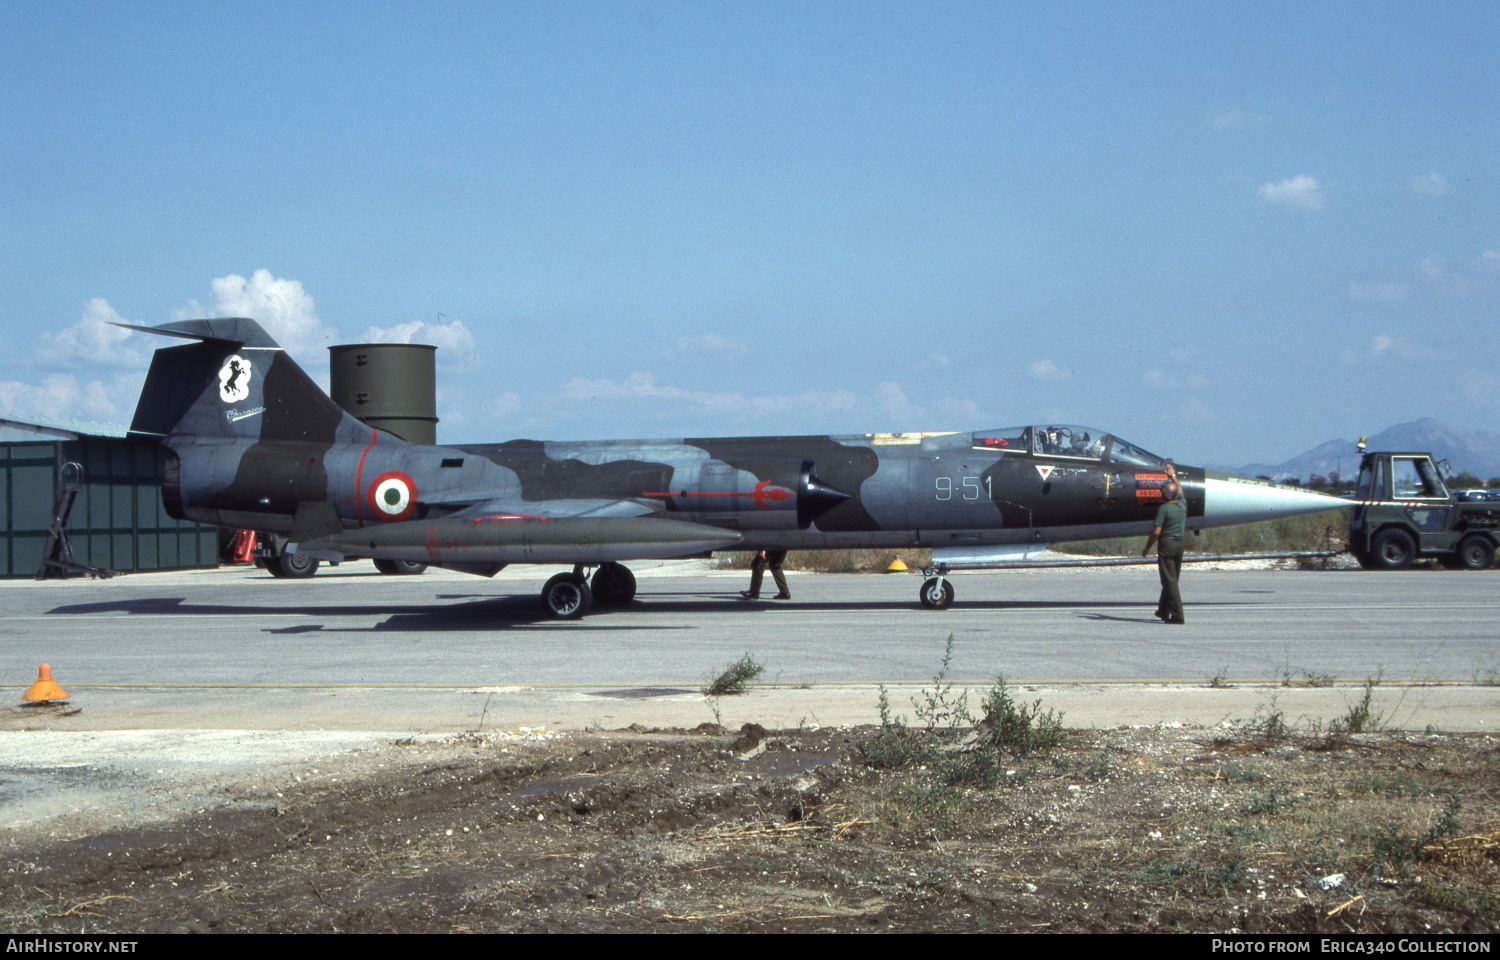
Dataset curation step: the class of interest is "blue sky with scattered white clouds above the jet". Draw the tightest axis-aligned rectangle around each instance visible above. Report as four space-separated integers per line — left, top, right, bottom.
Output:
0 0 1500 464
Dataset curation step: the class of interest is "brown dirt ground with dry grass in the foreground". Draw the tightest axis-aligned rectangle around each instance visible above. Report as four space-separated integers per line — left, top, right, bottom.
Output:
0 726 1500 933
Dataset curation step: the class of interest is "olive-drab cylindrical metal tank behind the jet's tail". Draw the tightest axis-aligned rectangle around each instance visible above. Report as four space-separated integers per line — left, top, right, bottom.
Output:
329 344 438 444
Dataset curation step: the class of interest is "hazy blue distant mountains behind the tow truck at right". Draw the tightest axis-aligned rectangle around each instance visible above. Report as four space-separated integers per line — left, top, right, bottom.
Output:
1217 417 1500 480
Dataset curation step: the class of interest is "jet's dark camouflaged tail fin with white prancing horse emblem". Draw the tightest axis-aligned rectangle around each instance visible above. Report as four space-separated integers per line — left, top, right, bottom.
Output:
120 317 381 444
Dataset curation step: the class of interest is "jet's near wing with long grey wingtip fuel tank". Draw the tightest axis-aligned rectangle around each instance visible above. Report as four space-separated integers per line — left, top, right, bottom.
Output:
296 500 741 575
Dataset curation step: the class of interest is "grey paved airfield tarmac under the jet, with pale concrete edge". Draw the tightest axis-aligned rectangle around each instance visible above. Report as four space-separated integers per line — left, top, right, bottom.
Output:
0 561 1500 734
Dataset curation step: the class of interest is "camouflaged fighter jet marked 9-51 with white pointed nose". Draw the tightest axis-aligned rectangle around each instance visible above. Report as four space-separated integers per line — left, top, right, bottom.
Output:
122 318 1344 618
